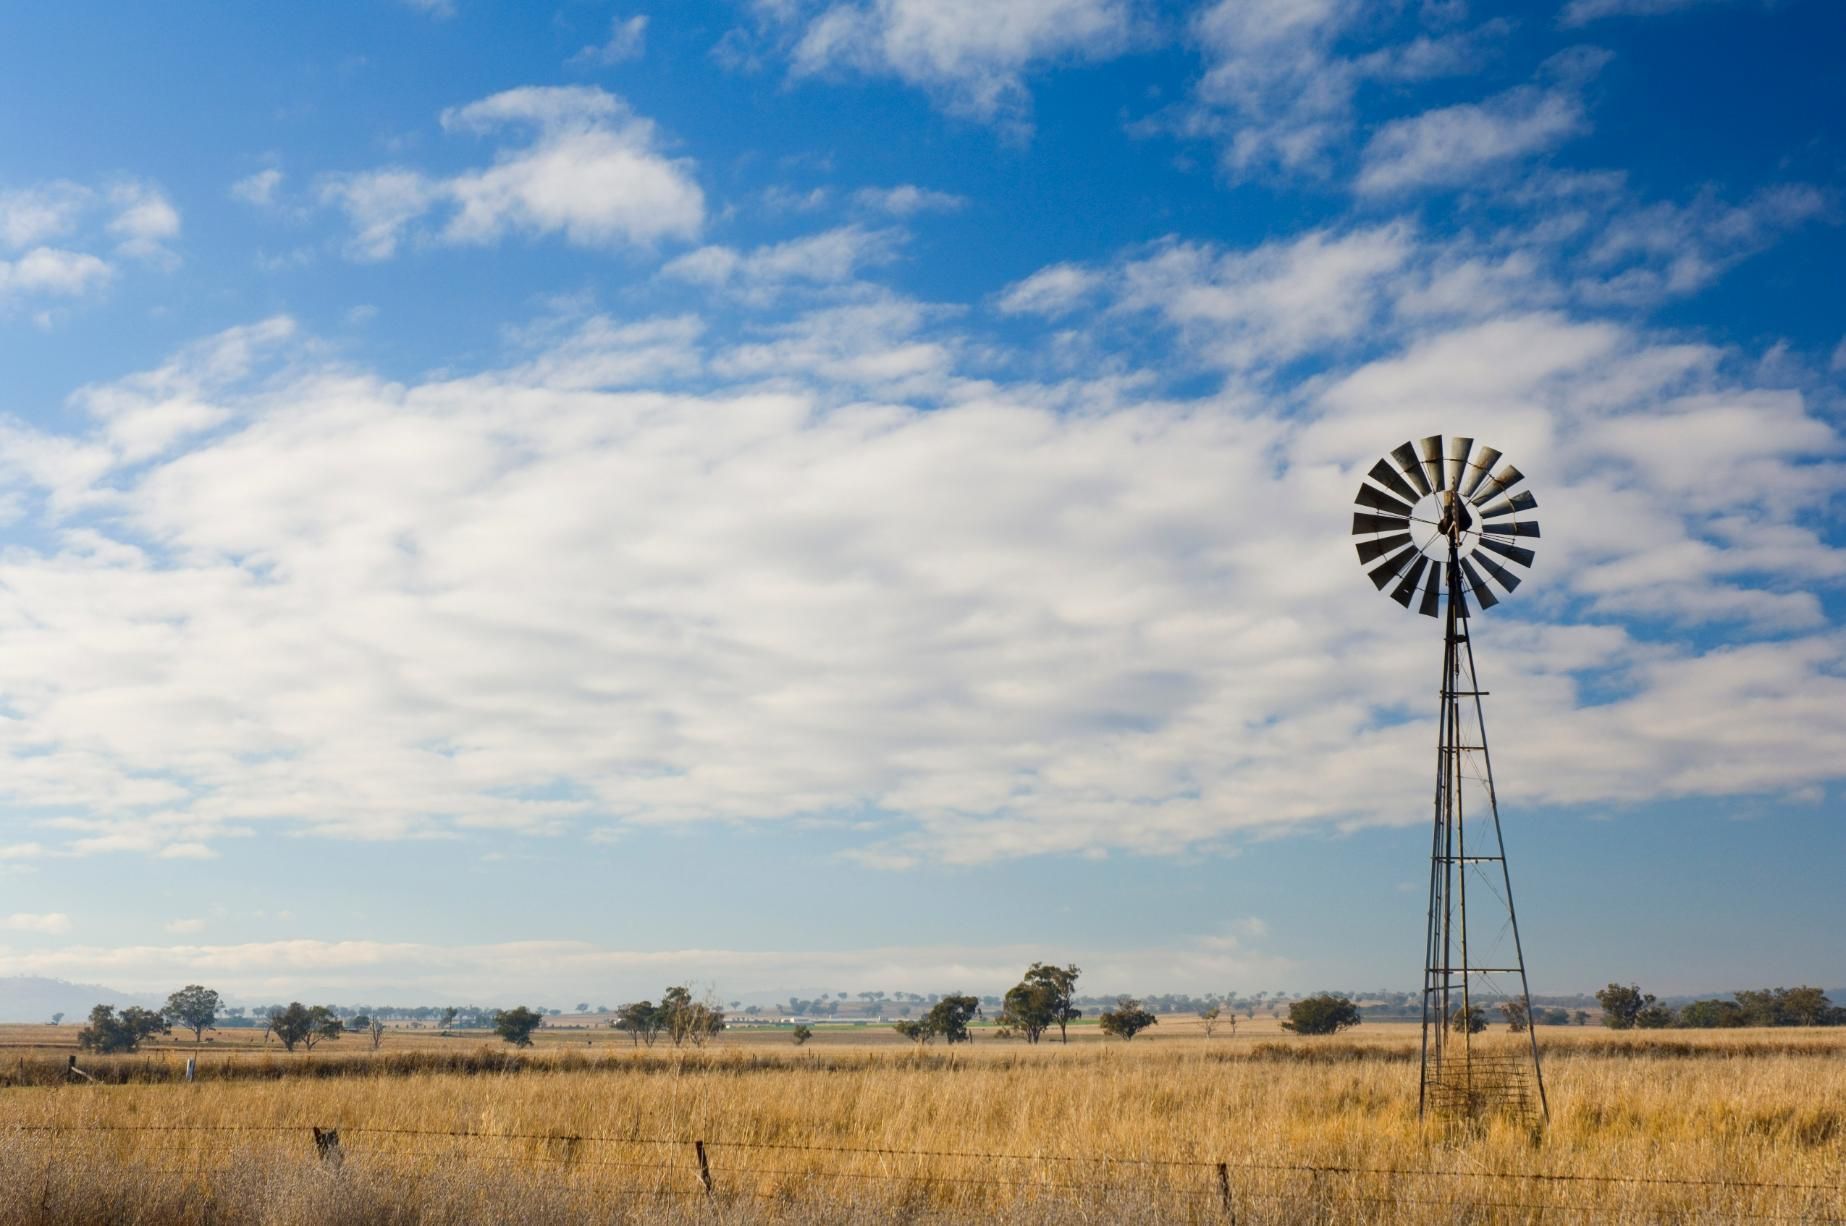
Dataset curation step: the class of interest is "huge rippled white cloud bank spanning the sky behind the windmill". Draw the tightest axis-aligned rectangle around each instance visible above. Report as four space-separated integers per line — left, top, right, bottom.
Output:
0 252 1846 875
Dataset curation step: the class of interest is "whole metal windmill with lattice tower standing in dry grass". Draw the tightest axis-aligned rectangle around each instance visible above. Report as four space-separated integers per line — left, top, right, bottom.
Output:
1353 434 1549 1123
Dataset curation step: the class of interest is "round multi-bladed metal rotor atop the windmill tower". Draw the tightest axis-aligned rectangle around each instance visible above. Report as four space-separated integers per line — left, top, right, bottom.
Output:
1353 434 1540 617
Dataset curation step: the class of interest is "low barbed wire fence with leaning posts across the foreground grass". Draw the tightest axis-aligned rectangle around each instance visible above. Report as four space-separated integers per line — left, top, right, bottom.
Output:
0 1121 1846 1224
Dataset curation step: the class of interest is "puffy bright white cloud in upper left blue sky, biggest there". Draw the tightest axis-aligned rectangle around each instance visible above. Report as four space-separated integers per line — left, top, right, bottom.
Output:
321 87 705 260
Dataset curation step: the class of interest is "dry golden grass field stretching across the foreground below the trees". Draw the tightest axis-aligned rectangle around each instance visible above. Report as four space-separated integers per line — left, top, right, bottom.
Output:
0 1017 1846 1226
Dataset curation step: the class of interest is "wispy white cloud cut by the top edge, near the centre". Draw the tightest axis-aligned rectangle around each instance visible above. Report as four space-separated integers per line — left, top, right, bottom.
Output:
768 0 1130 131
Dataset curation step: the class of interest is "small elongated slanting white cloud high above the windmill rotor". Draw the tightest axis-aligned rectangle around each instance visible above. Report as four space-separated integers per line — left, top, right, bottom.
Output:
1359 87 1588 194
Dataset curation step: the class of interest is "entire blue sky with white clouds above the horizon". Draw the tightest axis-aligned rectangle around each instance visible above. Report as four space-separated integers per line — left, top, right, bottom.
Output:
0 0 1846 1004
